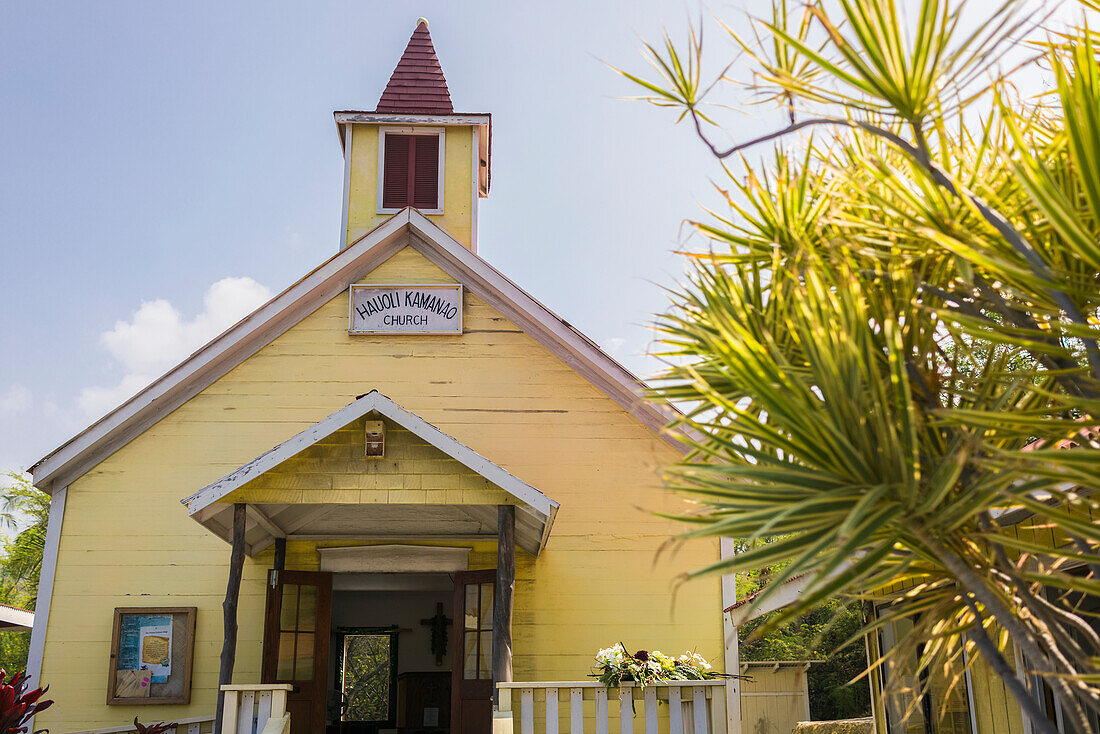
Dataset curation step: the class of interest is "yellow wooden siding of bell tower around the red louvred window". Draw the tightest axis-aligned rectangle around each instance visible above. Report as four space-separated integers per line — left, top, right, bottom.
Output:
347 123 474 248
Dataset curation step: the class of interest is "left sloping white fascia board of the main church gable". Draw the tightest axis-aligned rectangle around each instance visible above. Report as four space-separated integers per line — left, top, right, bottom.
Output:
30 211 408 492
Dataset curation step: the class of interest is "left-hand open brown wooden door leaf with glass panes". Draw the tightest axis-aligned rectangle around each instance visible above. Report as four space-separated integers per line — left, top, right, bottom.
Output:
261 571 332 734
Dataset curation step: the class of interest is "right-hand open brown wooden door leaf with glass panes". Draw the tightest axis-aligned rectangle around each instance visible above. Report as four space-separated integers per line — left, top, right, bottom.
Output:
451 569 496 734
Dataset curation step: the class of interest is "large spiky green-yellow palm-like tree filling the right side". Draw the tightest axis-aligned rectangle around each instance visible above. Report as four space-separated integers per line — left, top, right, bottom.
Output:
627 0 1100 732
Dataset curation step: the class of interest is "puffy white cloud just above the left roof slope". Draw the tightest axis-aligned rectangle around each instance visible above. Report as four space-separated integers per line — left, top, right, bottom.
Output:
78 277 272 417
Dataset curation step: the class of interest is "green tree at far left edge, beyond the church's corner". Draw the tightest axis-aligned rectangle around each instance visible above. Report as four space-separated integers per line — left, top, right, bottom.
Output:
0 472 50 670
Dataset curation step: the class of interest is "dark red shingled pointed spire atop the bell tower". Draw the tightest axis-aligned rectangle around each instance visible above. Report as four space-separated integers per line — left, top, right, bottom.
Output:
375 18 454 114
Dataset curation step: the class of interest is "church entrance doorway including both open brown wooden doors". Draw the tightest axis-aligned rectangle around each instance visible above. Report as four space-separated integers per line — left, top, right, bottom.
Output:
263 570 496 734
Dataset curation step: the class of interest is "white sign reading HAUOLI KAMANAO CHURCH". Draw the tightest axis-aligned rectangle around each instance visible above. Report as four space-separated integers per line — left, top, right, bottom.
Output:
348 284 462 333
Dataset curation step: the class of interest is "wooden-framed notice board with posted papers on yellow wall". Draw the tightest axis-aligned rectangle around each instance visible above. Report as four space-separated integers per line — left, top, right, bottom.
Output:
107 606 197 705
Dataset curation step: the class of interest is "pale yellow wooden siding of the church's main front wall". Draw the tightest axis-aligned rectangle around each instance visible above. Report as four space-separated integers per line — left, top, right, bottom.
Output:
36 244 723 734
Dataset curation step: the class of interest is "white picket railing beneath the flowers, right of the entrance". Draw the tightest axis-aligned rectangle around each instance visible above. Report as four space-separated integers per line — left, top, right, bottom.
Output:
494 680 726 734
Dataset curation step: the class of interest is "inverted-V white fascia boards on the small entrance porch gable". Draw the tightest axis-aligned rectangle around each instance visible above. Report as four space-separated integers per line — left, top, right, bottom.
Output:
180 391 559 519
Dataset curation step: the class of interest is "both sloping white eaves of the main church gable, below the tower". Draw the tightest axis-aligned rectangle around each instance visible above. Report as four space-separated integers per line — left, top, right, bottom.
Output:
30 208 686 493
